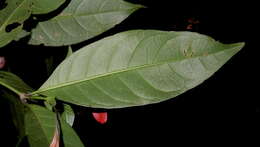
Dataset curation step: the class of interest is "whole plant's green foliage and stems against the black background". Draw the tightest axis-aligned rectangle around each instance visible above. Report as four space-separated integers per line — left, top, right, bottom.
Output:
0 0 244 147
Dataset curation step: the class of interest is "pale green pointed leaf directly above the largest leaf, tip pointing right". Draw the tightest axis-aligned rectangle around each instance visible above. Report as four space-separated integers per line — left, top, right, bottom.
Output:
29 0 141 46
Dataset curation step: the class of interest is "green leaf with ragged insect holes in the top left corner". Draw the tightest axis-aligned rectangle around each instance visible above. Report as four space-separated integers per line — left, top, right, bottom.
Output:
0 0 32 47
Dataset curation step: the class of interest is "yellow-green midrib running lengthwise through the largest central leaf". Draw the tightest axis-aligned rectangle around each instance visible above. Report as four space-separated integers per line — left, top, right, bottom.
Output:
31 43 240 95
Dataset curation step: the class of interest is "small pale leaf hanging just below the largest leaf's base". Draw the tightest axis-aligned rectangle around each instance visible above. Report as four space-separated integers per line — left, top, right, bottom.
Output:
61 104 75 126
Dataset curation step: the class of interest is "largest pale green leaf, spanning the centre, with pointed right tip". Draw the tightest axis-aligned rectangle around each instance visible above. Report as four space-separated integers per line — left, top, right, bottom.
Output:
34 30 244 108
